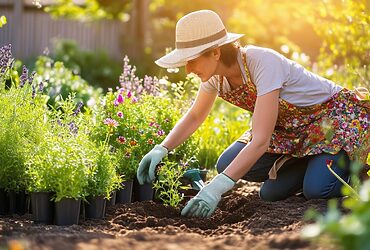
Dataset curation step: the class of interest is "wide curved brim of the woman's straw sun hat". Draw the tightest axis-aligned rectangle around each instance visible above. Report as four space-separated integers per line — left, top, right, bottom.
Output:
155 32 244 68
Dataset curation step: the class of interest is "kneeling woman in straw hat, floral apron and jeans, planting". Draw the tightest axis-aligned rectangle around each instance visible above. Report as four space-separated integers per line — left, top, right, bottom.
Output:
137 10 370 217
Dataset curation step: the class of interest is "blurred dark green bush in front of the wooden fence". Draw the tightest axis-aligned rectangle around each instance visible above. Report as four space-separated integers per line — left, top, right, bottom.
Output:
53 40 121 89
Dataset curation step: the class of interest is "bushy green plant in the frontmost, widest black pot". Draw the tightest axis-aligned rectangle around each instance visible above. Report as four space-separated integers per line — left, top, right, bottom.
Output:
40 95 96 225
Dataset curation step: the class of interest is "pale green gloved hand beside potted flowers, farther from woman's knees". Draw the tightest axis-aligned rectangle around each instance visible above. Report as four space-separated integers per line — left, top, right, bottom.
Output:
136 145 168 185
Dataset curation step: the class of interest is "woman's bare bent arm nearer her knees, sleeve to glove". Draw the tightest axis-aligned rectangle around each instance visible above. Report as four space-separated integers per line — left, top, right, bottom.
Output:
224 89 280 181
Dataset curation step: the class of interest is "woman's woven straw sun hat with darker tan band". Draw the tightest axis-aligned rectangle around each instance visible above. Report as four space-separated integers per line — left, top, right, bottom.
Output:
155 10 244 68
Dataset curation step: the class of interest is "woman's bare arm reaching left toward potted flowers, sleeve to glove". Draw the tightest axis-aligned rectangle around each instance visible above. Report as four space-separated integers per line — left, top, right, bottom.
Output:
161 88 217 150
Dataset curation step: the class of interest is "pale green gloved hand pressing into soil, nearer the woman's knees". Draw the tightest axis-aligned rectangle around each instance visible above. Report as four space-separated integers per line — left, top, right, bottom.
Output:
181 173 235 217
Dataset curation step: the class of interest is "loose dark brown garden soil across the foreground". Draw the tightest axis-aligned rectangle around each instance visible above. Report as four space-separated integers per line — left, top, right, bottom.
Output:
0 181 327 250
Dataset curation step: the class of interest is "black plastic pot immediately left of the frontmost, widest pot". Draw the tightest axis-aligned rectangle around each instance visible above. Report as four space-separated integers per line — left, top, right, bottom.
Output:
31 192 54 224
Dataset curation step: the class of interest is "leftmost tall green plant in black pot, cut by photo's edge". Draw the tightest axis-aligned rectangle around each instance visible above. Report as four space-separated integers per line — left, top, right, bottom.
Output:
0 57 46 214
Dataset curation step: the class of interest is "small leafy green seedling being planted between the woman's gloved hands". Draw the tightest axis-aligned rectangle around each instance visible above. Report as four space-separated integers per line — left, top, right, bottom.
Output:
153 161 186 207
